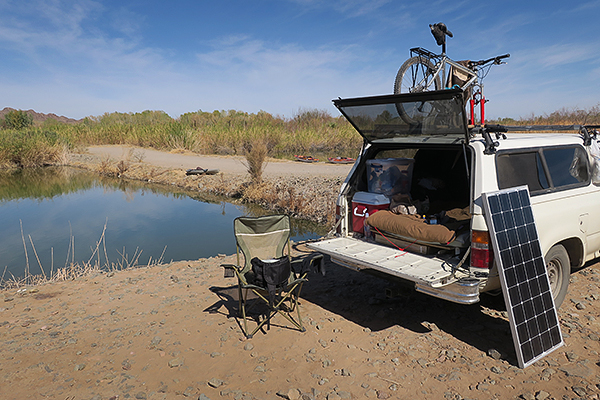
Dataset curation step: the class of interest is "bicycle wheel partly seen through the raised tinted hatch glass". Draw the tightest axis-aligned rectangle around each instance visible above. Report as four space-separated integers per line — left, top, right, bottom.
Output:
394 57 442 125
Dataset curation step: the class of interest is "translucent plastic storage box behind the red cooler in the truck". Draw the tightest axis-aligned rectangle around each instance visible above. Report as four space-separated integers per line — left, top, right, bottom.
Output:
367 158 415 197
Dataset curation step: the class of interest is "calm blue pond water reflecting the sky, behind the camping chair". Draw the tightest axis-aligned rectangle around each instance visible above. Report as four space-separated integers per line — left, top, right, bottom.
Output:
0 168 326 279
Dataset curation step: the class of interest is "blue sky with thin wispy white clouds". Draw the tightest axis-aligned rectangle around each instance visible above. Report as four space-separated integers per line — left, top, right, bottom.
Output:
0 0 600 118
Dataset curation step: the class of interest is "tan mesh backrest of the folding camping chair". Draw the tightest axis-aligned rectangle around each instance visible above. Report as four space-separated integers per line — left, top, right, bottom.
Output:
233 215 290 274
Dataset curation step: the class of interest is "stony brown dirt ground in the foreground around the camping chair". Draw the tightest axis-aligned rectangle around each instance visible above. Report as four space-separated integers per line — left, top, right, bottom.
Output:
0 148 600 400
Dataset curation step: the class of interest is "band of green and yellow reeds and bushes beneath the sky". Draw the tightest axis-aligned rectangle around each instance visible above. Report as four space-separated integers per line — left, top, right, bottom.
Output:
0 104 600 167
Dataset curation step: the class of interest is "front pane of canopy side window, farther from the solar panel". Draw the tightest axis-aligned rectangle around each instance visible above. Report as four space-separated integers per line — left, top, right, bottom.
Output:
543 147 589 188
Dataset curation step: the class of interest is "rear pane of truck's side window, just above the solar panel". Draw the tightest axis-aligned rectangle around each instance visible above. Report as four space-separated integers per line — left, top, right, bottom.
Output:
496 151 550 194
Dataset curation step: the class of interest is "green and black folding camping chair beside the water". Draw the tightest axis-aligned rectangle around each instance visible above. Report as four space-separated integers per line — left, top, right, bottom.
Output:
221 215 323 339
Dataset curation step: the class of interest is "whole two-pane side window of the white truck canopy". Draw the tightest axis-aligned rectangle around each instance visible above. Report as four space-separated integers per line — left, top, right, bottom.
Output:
496 146 590 195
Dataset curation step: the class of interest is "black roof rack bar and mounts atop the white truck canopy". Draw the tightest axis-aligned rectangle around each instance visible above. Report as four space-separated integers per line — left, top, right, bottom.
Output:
470 124 600 154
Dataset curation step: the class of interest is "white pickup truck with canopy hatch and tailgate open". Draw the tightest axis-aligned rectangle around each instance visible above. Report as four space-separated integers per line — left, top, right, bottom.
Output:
309 90 600 307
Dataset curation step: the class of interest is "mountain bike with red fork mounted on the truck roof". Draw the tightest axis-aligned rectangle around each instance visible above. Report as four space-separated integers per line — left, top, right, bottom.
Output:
394 22 510 126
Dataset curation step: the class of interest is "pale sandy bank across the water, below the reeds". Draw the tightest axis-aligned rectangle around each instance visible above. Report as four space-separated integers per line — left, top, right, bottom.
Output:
68 146 352 225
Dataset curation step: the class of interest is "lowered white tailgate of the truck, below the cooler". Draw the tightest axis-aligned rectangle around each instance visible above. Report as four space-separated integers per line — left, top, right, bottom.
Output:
307 237 458 287
